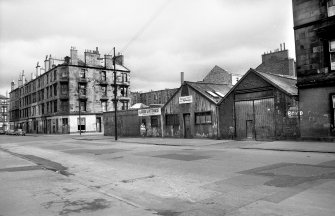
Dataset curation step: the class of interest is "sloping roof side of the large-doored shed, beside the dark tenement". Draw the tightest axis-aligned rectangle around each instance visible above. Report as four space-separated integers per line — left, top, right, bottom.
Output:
252 69 298 95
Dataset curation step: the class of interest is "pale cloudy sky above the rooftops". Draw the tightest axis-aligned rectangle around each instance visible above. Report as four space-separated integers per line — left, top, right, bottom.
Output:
0 0 295 94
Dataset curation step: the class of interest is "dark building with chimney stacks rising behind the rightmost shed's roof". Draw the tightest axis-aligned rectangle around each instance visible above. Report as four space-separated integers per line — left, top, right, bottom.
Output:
256 43 296 76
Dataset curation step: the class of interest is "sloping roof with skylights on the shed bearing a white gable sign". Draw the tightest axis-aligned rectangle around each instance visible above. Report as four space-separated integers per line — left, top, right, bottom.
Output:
185 81 231 104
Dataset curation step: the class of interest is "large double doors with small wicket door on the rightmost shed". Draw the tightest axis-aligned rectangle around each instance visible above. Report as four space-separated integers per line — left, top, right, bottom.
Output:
235 98 275 140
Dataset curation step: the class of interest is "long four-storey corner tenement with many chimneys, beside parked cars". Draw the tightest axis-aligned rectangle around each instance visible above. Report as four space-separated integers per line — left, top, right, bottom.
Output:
9 47 130 134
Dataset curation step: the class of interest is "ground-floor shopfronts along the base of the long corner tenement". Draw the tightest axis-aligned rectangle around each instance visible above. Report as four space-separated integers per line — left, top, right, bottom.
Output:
10 115 103 134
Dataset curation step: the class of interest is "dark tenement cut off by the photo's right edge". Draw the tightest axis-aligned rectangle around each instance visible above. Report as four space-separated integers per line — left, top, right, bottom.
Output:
293 0 335 139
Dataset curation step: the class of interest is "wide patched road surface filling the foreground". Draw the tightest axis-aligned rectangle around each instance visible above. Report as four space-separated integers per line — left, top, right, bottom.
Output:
0 135 335 216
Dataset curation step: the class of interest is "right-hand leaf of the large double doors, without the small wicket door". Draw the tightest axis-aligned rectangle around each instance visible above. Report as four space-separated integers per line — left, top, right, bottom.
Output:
254 98 275 140
